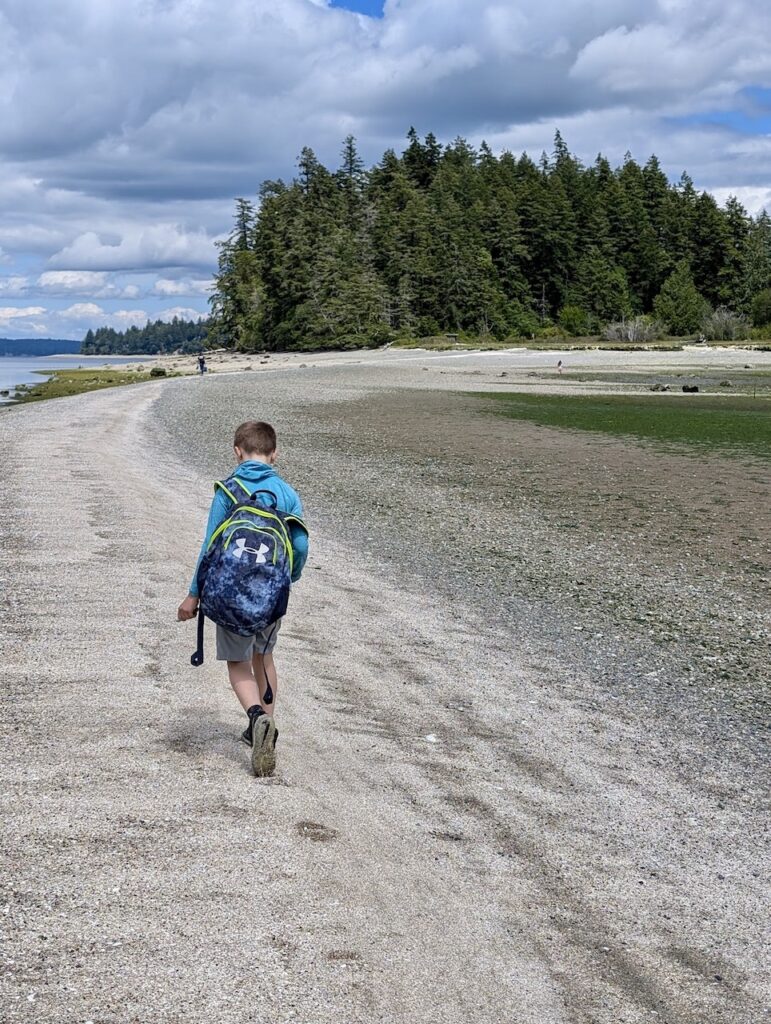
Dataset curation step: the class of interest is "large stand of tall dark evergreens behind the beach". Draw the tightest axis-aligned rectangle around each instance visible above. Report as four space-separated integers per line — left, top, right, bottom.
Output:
209 129 771 349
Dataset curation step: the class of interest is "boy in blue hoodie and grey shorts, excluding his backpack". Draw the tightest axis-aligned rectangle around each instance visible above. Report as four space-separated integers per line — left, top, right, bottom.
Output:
177 421 308 775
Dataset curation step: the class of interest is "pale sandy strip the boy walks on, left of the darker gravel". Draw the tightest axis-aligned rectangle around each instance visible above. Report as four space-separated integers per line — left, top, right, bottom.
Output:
0 382 764 1024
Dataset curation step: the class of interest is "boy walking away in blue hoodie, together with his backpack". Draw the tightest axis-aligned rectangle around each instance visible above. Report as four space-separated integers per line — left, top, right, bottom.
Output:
177 421 308 775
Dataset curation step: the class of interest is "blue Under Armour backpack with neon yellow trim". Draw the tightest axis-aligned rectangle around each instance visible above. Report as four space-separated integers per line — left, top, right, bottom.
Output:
190 476 307 666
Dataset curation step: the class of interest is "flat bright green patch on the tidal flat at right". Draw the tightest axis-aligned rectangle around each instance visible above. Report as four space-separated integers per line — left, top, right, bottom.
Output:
471 392 771 459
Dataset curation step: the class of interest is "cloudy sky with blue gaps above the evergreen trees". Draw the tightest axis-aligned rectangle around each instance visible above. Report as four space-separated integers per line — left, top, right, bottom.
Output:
0 0 771 338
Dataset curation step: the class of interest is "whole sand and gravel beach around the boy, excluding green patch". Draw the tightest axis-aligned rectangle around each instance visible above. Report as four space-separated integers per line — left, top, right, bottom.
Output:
0 351 771 1024
